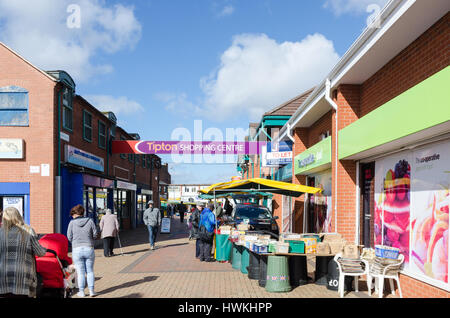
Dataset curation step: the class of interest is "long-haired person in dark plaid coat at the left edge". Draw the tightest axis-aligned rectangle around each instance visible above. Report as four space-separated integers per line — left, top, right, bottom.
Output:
0 207 47 298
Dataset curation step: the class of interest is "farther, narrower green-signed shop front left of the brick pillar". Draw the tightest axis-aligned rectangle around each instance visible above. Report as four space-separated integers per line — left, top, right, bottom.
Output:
294 137 333 233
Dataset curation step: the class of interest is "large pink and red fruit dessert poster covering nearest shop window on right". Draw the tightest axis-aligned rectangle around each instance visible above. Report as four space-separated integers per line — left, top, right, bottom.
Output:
374 142 450 289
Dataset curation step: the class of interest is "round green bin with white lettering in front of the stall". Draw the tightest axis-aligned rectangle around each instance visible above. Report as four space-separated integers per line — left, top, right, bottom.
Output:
266 255 292 293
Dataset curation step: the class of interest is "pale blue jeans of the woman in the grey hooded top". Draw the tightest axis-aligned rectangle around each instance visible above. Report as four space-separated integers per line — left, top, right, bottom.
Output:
72 246 95 291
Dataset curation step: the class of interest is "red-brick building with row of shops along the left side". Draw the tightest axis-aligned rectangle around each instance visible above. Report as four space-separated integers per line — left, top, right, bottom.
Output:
0 43 170 233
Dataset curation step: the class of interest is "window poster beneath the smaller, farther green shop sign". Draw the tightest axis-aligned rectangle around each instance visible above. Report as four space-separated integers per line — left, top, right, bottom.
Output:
313 170 332 233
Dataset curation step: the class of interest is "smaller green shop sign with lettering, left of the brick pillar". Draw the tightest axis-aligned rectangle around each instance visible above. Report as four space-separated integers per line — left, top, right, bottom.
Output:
294 137 331 175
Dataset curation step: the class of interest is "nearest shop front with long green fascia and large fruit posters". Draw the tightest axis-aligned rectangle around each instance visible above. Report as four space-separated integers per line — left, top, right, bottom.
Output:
339 67 450 292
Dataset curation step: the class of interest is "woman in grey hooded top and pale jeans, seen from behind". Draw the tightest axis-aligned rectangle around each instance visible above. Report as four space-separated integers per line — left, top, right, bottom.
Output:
67 204 98 297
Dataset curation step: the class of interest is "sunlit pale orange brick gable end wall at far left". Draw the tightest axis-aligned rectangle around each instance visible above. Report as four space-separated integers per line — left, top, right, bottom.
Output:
0 45 56 233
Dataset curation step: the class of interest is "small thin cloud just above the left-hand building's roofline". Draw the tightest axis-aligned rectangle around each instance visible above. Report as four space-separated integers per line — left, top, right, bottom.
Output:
83 95 144 115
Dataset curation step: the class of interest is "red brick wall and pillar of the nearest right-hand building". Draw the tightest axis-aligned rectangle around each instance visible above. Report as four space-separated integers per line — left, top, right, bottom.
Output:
332 13 450 298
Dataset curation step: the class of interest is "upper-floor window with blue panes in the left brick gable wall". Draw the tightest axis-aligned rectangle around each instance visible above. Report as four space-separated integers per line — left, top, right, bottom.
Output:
0 86 29 126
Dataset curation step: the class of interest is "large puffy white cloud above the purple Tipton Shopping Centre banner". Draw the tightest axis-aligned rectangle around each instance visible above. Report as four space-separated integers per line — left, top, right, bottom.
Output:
200 34 339 120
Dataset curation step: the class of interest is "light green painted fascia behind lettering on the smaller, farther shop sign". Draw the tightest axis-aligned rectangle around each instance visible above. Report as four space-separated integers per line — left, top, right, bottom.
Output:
294 136 331 175
